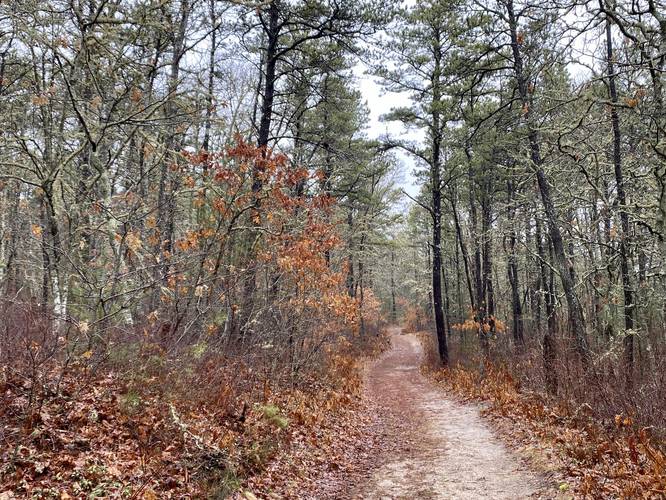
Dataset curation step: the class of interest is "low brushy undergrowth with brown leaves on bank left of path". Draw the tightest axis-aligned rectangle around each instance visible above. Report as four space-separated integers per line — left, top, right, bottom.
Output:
0 330 383 500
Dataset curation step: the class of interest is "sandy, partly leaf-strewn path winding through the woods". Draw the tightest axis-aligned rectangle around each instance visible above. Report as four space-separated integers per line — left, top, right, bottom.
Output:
352 328 542 500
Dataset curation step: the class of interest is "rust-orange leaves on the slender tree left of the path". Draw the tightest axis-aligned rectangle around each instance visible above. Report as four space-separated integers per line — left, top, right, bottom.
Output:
179 137 364 338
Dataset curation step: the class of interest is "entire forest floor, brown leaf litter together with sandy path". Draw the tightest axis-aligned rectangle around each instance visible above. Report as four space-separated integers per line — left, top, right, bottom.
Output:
0 327 666 500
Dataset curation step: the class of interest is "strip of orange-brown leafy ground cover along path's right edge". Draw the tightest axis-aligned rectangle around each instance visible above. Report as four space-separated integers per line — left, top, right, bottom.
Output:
422 334 666 499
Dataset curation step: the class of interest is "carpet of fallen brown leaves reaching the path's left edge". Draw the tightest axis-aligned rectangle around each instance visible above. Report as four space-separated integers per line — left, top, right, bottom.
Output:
0 332 386 500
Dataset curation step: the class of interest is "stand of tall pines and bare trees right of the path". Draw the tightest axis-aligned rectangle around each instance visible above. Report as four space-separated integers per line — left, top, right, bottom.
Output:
370 0 666 425
